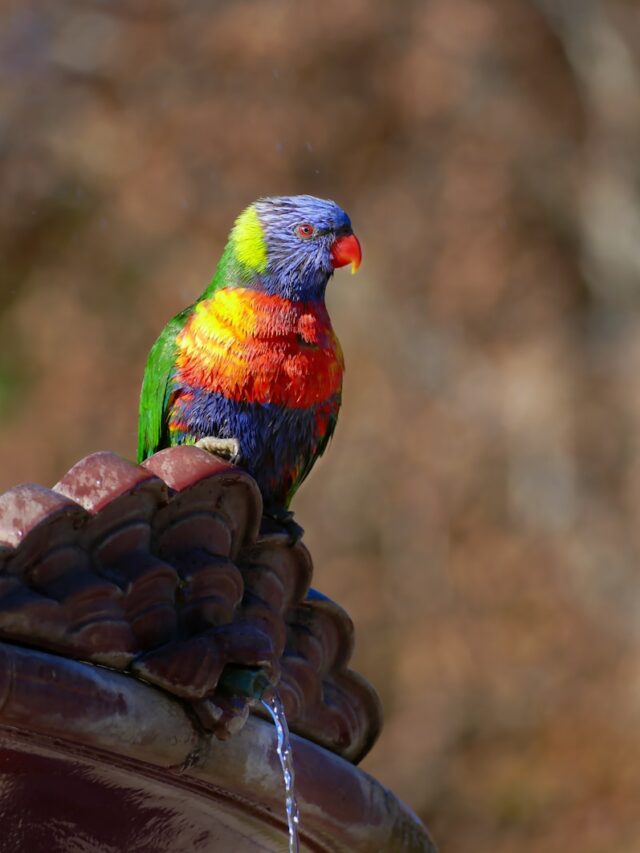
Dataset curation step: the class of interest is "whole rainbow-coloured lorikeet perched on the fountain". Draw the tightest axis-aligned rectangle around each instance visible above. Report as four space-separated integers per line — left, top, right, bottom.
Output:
138 195 361 520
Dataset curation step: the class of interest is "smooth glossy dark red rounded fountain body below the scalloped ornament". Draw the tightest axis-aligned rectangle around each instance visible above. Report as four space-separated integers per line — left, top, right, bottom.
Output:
0 644 434 853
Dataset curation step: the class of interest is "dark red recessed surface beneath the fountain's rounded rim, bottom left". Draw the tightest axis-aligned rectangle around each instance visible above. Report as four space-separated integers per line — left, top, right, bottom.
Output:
0 732 282 853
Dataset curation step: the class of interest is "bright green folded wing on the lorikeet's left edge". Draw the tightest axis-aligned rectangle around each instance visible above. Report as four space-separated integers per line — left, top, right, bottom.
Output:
138 305 194 462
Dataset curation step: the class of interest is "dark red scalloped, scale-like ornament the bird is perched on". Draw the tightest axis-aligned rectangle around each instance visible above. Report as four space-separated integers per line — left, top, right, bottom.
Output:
0 447 382 761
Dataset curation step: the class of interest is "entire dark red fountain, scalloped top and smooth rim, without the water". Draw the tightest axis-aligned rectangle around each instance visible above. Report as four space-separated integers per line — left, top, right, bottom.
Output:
0 448 434 853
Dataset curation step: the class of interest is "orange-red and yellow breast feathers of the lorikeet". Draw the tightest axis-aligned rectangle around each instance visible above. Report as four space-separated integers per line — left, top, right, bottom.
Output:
176 288 344 408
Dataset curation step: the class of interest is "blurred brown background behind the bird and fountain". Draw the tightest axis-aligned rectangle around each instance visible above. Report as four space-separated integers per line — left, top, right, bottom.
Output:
0 0 640 853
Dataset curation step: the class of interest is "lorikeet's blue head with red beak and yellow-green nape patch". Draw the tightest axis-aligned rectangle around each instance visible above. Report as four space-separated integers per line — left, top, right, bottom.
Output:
230 195 362 300
